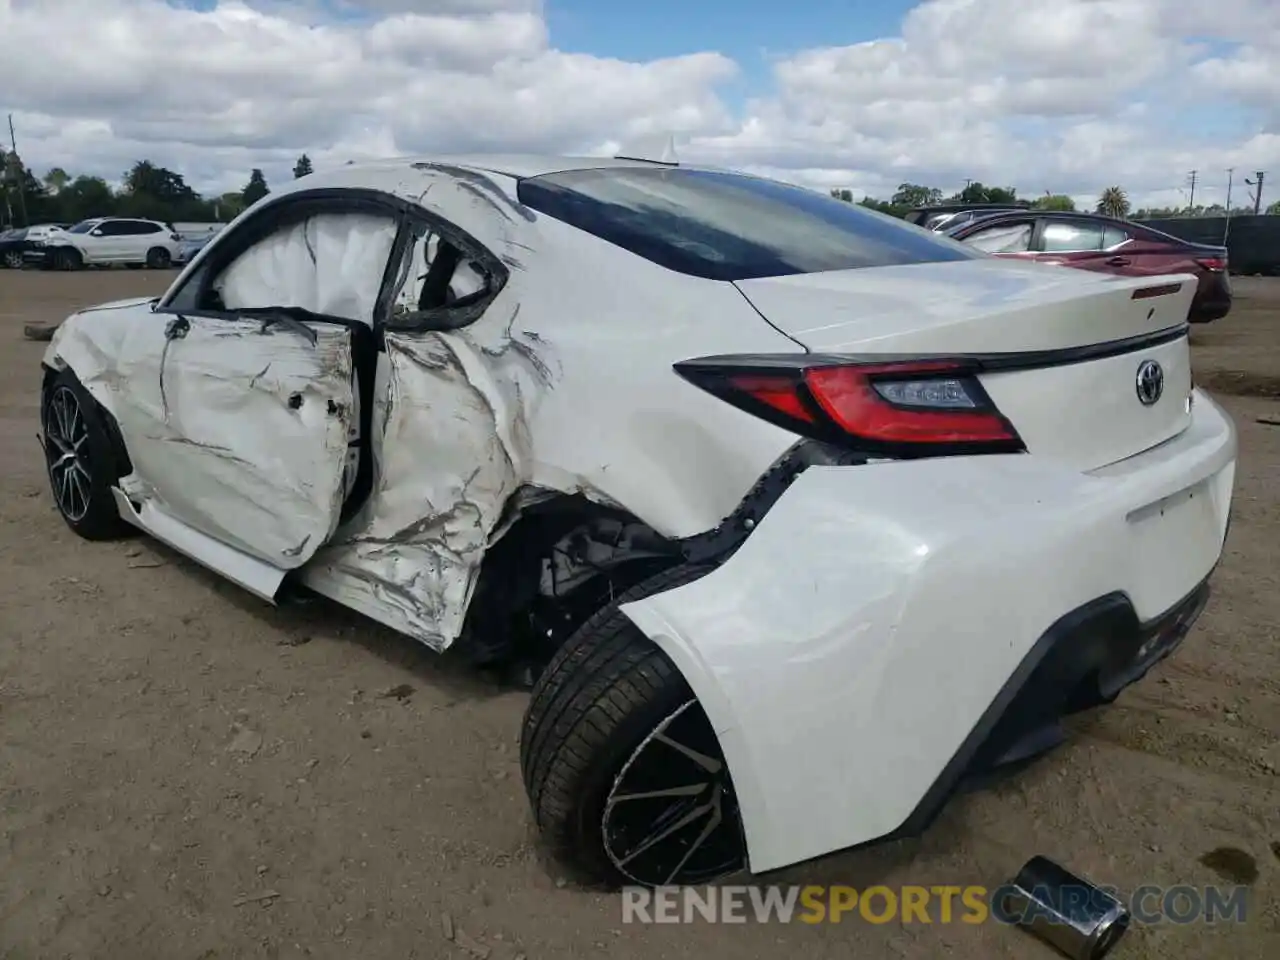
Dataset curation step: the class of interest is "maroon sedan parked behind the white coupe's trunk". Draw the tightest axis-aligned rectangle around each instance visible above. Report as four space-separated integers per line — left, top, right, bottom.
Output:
945 210 1231 324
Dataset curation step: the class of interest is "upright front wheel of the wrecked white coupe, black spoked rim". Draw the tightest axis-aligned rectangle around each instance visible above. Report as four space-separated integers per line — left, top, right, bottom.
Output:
40 370 133 540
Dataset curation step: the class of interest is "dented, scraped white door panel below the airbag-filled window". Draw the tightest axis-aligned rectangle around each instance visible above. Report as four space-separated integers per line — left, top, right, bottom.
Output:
144 314 355 570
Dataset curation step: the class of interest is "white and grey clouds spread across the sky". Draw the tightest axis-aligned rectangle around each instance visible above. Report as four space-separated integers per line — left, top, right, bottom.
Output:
0 0 1280 202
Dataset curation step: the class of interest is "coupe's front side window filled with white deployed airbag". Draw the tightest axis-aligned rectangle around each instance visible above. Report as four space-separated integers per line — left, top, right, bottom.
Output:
201 211 398 325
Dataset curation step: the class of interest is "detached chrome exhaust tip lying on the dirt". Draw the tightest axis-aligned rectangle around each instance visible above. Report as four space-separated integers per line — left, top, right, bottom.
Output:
996 856 1132 960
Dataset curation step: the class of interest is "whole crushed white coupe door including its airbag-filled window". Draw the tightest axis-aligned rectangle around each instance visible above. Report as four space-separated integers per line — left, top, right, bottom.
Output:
120 192 399 598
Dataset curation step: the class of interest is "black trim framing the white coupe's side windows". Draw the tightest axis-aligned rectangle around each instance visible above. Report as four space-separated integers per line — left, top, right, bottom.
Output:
152 187 509 340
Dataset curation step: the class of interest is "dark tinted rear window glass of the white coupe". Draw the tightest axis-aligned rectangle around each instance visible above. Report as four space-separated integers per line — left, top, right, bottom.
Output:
518 166 983 280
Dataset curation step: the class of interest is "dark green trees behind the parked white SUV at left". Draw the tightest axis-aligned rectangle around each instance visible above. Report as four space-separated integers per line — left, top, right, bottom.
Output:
0 150 312 225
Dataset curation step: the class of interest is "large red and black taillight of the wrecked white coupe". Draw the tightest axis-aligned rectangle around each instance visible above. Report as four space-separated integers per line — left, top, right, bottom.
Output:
676 356 1025 457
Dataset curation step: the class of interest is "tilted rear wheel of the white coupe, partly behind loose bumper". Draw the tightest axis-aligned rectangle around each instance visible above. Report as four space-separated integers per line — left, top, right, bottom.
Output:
520 566 745 887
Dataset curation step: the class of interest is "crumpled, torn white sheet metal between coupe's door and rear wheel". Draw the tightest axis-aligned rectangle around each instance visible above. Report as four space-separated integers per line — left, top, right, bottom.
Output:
303 321 539 649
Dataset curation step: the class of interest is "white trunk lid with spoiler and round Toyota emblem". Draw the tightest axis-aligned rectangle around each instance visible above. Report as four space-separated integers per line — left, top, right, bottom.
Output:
737 257 1197 470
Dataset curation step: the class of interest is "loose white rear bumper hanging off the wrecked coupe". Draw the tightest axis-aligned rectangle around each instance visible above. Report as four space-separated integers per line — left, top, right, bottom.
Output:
623 392 1236 872
